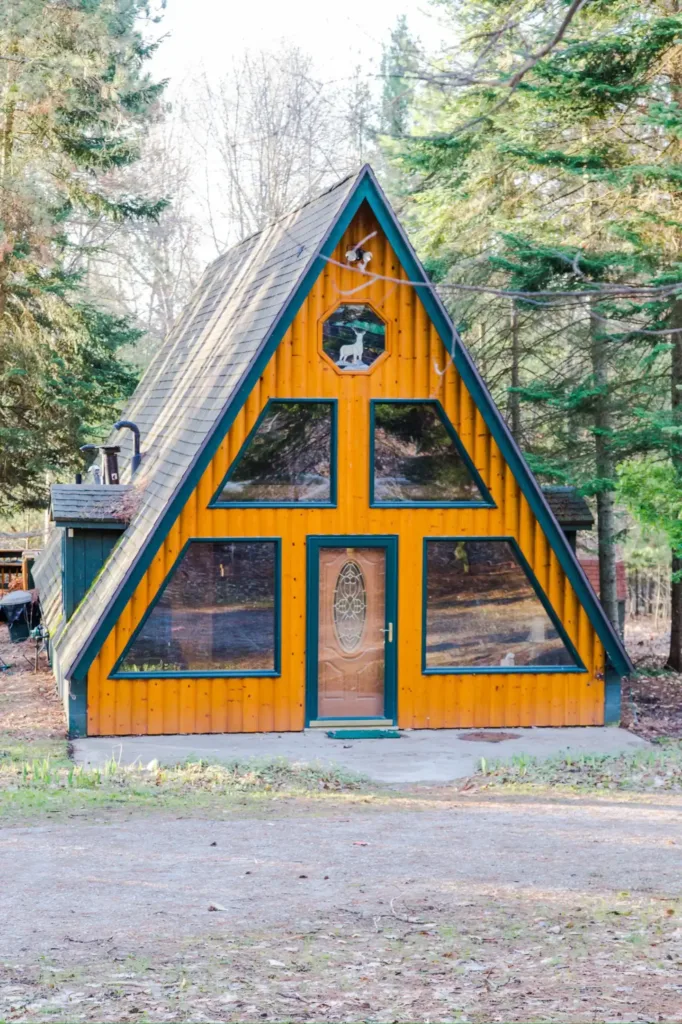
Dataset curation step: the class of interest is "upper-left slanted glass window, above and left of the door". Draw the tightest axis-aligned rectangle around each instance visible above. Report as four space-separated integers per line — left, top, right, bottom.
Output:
216 401 334 505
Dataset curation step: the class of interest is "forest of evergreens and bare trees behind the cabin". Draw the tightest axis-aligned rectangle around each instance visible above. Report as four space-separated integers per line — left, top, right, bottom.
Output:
0 0 682 671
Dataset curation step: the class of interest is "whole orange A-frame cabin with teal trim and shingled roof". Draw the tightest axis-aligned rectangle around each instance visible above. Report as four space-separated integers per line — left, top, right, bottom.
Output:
37 167 631 735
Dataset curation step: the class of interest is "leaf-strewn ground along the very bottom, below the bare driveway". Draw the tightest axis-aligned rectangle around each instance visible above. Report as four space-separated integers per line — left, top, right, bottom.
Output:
0 890 682 1024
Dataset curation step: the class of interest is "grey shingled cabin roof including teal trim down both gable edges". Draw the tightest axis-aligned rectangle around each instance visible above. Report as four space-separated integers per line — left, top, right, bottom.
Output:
53 166 631 679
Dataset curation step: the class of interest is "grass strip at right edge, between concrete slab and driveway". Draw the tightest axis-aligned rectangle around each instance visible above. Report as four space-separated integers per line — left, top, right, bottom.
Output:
473 740 682 793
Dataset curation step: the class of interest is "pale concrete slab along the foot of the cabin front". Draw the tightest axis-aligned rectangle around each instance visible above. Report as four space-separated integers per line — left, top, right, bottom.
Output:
74 726 649 784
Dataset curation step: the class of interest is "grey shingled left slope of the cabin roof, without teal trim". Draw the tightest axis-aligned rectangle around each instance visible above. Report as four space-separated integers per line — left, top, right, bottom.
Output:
53 165 364 676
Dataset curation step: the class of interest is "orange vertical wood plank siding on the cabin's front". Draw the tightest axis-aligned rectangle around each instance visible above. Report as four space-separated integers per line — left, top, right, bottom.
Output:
88 206 604 735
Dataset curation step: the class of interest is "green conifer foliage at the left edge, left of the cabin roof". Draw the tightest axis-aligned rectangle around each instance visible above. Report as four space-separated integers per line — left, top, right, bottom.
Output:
0 0 166 512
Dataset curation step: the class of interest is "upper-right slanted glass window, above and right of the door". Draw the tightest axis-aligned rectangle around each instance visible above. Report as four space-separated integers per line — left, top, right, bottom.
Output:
372 401 493 505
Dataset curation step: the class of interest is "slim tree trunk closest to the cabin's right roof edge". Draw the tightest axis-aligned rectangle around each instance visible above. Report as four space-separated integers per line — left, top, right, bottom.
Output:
590 299 620 630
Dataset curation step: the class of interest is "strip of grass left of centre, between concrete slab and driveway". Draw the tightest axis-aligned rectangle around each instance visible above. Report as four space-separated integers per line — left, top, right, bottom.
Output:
0 749 369 818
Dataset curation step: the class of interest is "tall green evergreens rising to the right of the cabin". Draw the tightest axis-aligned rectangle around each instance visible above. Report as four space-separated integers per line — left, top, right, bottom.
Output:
391 0 682 665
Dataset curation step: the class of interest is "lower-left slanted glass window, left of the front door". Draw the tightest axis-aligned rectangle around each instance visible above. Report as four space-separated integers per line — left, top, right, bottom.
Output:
115 541 279 675
